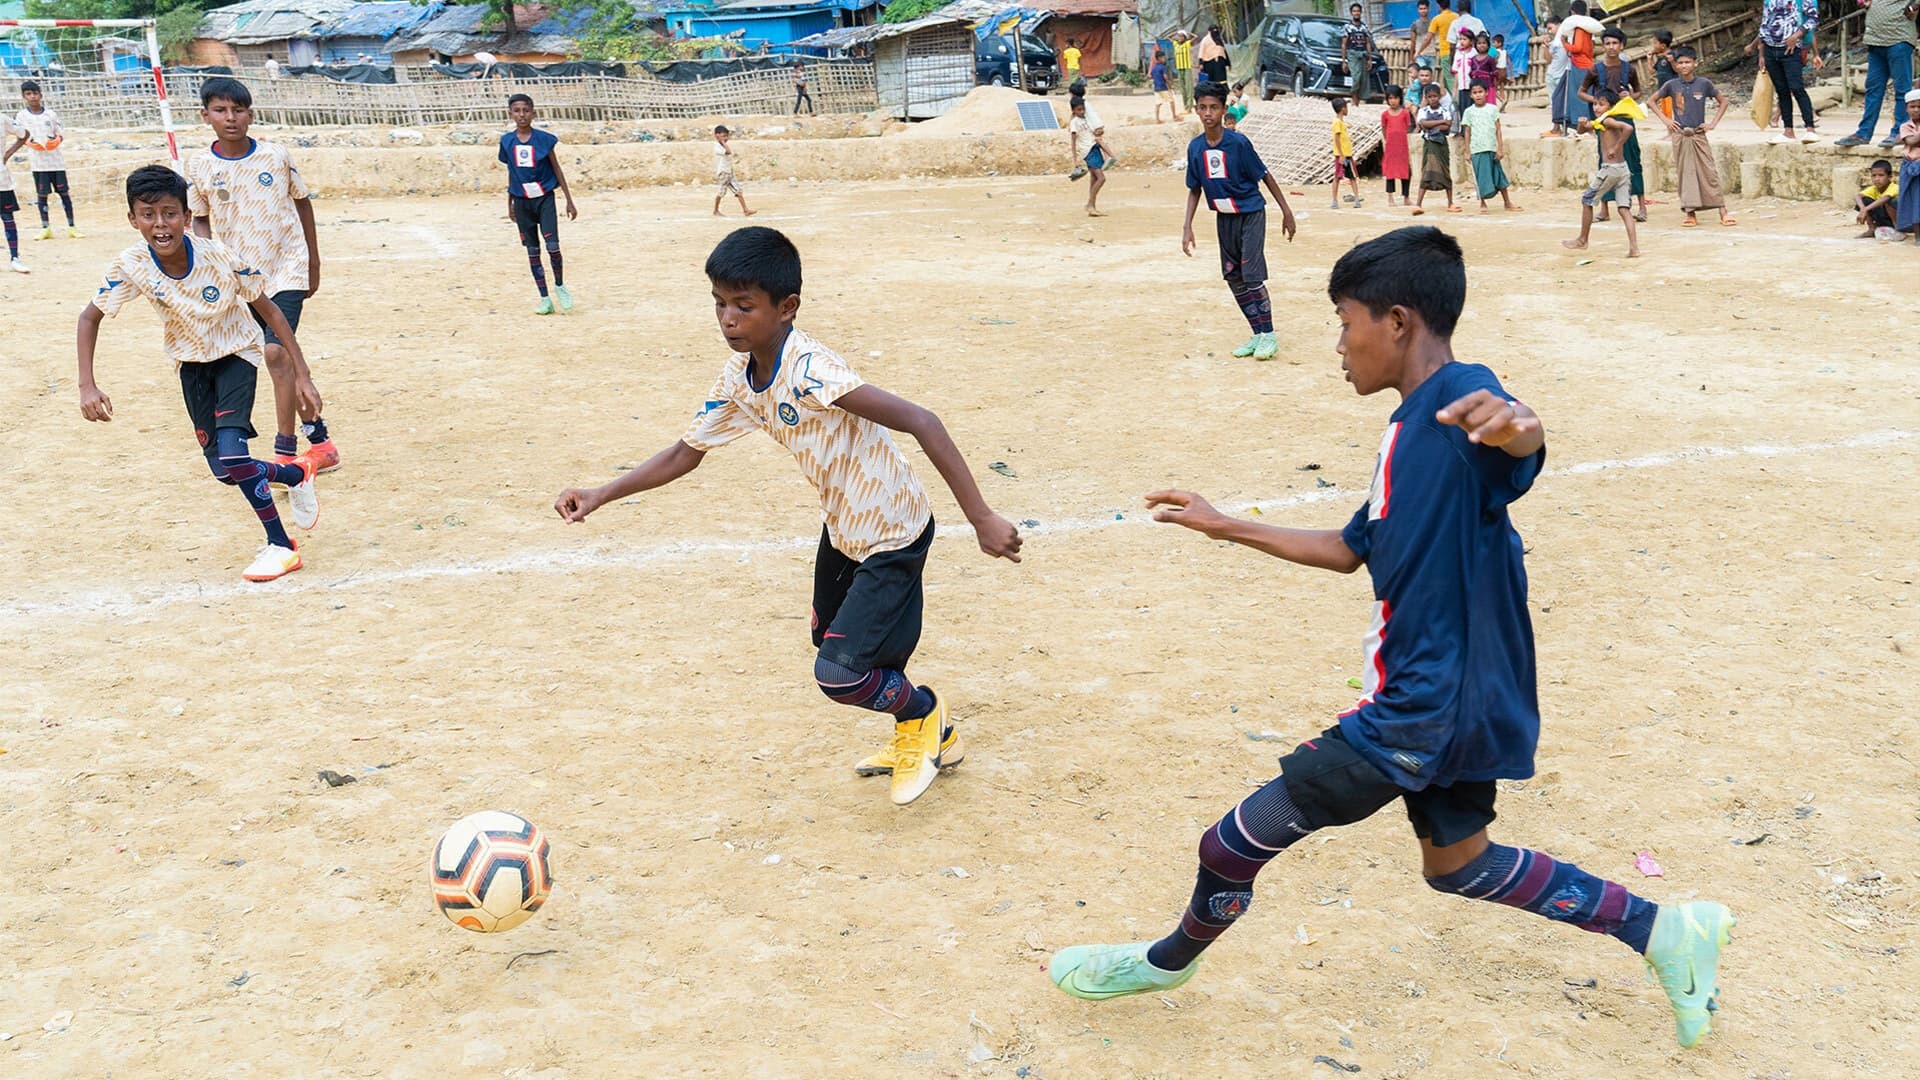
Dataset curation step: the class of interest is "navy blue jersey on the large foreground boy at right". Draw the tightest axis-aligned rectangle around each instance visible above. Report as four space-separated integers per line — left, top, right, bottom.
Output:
1340 363 1546 790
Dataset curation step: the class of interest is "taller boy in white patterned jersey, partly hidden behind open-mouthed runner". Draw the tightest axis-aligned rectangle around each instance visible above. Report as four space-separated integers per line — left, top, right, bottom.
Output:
186 79 340 473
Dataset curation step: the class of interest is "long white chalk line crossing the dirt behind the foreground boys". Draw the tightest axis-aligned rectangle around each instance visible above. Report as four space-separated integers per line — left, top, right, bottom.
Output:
0 430 1916 625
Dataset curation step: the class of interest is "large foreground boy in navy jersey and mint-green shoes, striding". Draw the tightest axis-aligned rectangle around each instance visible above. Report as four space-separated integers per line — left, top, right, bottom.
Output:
1050 227 1734 1045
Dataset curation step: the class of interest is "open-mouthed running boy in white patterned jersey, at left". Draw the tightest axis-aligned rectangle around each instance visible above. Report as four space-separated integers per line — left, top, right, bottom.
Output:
79 165 321 580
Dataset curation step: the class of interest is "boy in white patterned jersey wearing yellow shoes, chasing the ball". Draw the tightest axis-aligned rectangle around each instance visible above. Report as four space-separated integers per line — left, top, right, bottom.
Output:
553 227 1020 805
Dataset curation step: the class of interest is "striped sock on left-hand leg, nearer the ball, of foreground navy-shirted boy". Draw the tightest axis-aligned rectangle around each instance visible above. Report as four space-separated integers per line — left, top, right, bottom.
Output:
1146 778 1313 970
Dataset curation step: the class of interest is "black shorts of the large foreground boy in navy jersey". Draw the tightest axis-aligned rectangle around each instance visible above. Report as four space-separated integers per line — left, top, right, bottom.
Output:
1281 728 1494 847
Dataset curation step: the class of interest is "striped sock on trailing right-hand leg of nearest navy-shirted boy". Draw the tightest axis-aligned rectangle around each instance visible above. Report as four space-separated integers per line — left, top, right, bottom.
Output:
1427 844 1659 953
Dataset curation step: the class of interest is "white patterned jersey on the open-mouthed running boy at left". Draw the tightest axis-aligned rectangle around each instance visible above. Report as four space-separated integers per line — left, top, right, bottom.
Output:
94 236 267 367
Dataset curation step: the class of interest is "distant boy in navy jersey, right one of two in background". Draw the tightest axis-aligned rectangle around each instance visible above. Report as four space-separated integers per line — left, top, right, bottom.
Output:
1181 83 1294 359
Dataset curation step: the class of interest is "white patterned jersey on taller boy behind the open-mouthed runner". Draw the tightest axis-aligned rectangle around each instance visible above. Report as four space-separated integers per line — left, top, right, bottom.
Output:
186 140 307 296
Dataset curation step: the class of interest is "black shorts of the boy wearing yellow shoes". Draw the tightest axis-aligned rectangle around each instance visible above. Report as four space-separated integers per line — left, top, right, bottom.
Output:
812 521 933 671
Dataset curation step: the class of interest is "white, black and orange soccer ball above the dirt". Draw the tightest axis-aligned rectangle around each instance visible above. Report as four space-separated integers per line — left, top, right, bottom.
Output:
432 811 553 934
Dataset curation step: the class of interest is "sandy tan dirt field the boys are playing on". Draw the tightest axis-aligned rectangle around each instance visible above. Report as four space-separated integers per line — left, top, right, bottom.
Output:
0 173 1920 1078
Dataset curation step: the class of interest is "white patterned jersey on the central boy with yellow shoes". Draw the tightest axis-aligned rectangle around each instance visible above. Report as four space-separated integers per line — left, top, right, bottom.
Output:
682 331 933 561
